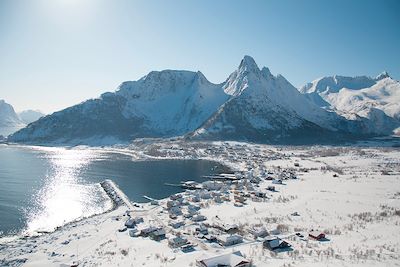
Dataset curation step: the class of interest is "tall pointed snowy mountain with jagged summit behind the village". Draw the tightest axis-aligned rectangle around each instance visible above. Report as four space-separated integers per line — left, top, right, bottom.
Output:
189 56 370 143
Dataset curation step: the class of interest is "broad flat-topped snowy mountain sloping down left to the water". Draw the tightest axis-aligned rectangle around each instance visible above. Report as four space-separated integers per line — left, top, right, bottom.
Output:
10 70 228 144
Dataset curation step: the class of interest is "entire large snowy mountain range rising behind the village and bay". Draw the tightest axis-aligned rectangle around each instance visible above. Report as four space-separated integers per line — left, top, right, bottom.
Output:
9 56 400 145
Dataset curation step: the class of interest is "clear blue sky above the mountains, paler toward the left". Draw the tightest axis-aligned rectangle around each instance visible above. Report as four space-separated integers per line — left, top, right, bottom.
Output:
0 0 400 113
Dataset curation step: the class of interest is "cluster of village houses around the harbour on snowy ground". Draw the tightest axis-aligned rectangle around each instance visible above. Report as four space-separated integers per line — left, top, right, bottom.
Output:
101 163 320 267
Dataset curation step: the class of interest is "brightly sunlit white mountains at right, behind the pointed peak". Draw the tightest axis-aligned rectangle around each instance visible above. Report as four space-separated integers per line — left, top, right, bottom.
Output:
300 72 400 132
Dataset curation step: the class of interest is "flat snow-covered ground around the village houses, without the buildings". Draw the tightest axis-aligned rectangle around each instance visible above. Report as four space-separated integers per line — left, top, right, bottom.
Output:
0 140 400 266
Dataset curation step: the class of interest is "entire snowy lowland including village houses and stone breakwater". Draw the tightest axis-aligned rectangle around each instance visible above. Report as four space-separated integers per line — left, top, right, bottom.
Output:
0 142 400 267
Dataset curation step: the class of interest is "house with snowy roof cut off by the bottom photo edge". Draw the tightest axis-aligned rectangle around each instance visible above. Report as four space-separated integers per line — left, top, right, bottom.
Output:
196 251 252 267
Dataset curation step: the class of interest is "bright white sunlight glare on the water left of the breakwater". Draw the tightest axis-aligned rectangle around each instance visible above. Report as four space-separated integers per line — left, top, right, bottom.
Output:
25 148 112 234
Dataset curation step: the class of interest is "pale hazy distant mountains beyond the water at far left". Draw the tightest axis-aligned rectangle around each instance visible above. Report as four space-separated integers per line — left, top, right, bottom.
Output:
0 100 44 136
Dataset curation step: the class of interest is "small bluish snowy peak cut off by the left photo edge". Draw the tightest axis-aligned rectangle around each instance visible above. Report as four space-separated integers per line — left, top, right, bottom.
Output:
0 100 25 136
